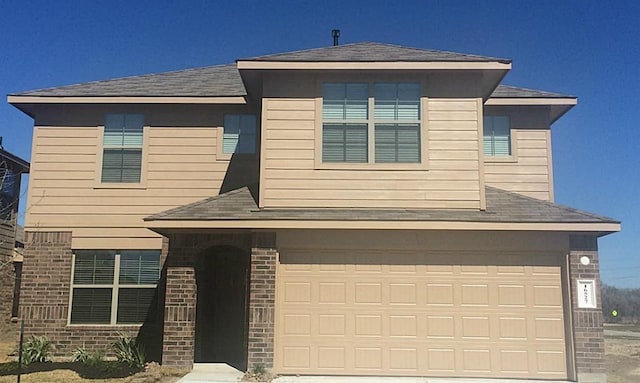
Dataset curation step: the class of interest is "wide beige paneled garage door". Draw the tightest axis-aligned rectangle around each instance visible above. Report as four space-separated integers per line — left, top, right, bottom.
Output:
275 252 567 379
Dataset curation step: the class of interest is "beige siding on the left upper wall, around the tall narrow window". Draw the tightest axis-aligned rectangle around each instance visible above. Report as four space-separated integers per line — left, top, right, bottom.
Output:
25 105 257 249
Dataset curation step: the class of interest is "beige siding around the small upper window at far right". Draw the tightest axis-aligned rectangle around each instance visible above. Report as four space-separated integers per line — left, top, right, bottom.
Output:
484 108 553 201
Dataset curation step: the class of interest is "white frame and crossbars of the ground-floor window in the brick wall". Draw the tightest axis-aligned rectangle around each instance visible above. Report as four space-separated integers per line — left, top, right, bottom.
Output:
67 250 161 327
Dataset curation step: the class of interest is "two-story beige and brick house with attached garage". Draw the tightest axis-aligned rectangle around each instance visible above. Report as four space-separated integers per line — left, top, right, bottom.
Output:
8 43 620 382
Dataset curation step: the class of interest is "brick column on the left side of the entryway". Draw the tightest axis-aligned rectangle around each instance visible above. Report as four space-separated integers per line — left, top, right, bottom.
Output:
162 248 197 368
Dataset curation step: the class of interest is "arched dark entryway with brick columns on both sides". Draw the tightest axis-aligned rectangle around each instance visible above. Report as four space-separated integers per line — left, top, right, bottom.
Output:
162 230 277 371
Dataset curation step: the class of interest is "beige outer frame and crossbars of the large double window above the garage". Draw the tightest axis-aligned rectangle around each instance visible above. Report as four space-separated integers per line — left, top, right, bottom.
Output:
314 76 428 170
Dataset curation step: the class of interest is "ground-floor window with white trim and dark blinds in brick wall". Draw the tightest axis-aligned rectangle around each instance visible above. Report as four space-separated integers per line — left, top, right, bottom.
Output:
70 250 160 324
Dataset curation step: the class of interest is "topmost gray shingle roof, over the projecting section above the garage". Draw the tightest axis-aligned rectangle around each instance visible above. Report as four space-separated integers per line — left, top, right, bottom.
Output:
238 42 511 63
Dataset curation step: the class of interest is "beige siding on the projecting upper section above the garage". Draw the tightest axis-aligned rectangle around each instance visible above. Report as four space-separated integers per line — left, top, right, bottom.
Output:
260 76 480 209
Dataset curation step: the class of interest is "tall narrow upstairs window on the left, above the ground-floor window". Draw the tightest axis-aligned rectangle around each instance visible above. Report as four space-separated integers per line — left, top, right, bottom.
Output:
101 114 144 183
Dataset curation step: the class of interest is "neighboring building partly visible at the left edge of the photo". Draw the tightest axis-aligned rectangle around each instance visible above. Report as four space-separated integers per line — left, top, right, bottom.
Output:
0 146 29 331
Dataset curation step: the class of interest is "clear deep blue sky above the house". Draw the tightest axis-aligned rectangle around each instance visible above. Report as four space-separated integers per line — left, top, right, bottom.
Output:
0 0 640 287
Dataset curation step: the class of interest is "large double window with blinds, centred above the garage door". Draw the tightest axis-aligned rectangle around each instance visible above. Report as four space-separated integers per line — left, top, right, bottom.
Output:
322 83 421 163
